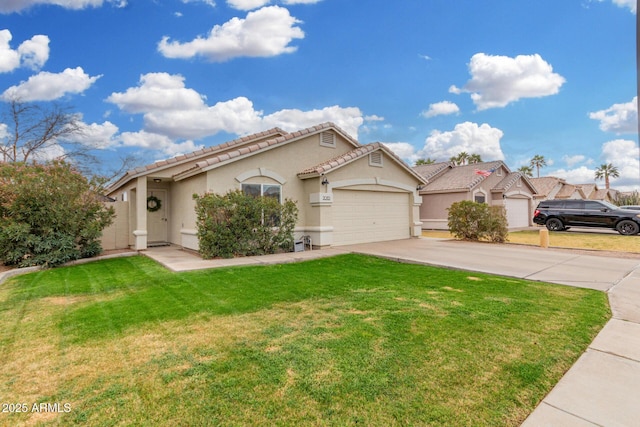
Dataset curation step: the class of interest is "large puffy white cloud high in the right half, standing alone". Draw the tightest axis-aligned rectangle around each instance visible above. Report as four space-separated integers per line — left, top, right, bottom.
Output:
449 53 565 110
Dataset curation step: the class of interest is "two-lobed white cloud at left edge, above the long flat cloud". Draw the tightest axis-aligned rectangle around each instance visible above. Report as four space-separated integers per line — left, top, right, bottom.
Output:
0 30 49 73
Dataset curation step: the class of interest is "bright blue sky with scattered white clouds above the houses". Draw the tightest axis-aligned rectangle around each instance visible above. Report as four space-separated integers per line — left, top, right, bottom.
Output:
0 0 640 190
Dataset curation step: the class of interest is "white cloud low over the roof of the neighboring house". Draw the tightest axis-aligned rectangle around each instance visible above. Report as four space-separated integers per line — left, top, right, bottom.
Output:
418 122 504 161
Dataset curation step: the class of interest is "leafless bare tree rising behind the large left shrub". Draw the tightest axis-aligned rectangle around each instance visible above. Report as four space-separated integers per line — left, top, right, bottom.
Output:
0 99 82 162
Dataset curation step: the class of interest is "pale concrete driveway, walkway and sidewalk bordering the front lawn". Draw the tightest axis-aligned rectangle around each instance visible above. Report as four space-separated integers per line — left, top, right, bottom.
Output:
145 237 640 427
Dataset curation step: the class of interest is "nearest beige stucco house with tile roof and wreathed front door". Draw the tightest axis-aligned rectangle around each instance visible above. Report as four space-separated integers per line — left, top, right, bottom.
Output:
107 123 425 250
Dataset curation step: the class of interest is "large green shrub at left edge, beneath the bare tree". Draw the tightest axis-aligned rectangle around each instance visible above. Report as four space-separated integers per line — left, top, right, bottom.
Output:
0 161 113 267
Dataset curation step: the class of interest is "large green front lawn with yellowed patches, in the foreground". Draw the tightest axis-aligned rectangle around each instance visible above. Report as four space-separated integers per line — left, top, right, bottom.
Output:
0 255 609 426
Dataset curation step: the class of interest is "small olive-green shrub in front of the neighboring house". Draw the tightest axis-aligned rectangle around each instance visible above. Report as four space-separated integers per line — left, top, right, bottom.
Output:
448 200 507 243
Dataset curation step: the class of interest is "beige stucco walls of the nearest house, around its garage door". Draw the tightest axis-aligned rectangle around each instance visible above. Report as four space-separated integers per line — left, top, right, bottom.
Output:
110 133 421 250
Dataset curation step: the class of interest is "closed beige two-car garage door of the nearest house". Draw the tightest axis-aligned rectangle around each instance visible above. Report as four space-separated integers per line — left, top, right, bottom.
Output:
332 190 410 245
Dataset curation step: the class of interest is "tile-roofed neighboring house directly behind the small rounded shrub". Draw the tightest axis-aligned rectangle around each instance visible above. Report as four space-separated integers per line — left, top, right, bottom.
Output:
414 161 536 230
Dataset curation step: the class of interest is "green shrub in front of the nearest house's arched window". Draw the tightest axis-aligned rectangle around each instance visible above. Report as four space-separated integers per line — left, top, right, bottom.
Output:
193 190 298 258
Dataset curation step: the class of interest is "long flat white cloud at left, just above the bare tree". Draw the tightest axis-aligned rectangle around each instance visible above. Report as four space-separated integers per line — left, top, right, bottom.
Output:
2 67 101 102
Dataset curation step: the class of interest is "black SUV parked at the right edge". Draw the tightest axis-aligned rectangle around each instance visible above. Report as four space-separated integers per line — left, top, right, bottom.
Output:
533 199 640 236
